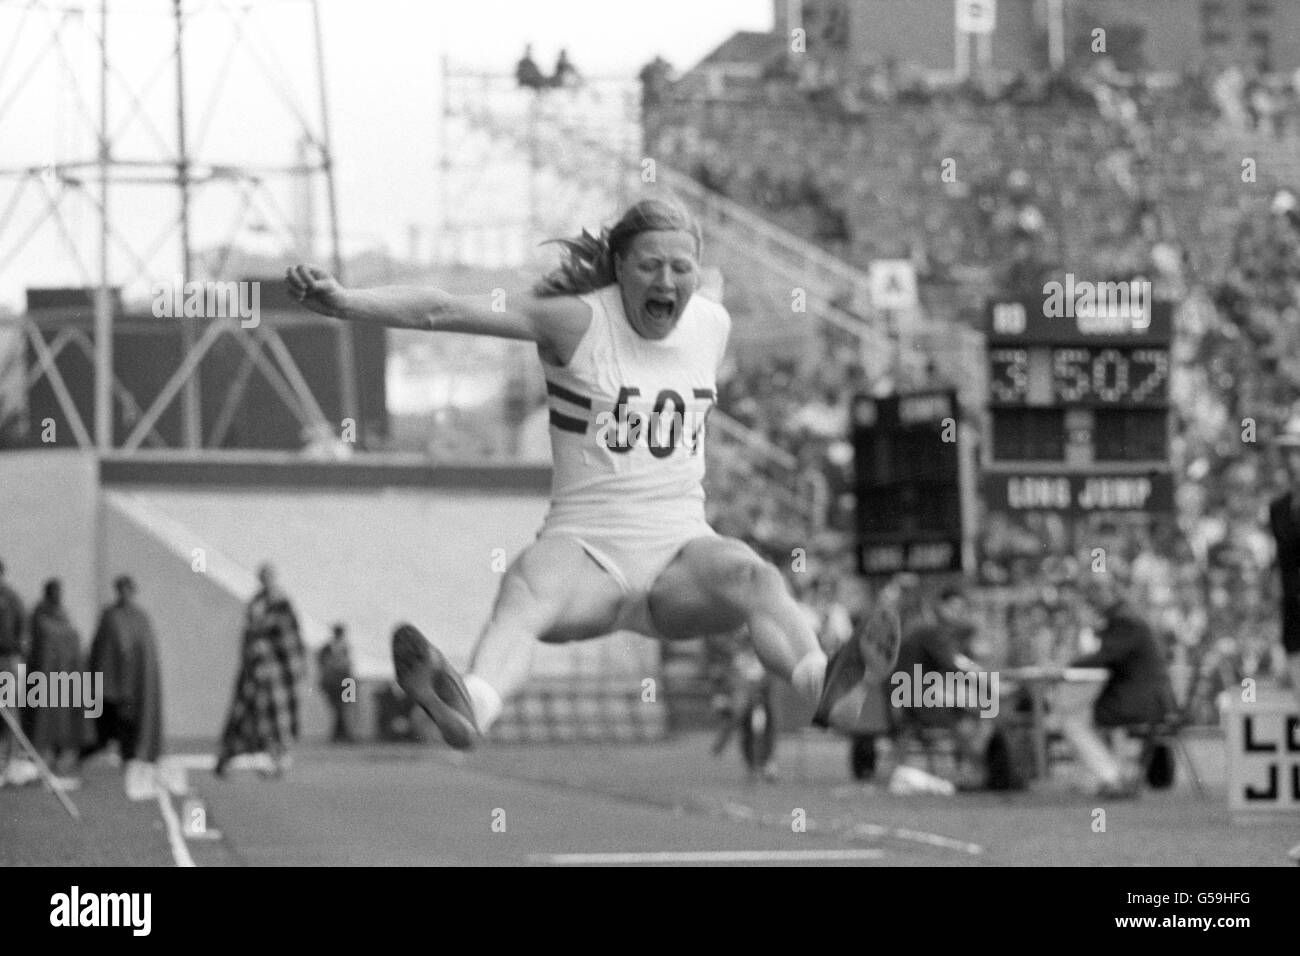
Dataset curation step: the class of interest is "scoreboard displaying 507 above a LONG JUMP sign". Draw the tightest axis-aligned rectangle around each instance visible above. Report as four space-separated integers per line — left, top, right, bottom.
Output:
982 298 1174 512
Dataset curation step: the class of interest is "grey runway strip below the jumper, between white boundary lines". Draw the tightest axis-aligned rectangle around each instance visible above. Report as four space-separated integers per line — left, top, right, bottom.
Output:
172 747 904 866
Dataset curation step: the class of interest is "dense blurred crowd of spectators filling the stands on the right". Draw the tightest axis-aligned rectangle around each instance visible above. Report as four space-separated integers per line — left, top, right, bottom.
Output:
646 52 1300 721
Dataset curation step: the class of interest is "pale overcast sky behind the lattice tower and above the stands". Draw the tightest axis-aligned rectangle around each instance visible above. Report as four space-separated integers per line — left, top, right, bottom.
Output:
0 0 772 303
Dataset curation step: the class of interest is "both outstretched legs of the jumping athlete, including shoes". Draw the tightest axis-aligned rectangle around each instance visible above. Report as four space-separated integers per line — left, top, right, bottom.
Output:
394 537 898 747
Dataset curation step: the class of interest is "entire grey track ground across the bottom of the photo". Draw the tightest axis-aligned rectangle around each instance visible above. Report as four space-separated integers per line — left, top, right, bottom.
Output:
0 734 1295 866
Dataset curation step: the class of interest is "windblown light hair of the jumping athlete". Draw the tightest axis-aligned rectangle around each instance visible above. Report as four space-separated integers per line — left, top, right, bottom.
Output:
533 199 703 298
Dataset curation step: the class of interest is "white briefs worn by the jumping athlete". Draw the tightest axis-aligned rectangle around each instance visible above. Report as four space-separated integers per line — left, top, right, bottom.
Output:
537 522 718 637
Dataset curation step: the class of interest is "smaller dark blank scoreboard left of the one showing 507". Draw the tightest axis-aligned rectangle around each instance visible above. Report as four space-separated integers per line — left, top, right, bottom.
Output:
852 389 963 575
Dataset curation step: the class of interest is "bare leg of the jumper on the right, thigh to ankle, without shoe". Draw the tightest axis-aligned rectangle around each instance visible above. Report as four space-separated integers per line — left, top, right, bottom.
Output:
649 537 822 680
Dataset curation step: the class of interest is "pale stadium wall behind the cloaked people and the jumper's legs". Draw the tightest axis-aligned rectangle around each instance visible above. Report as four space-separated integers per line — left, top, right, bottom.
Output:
0 450 664 749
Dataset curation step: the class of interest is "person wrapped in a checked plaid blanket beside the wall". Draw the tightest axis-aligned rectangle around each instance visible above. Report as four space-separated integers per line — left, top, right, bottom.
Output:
216 564 304 777
